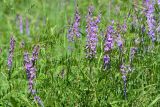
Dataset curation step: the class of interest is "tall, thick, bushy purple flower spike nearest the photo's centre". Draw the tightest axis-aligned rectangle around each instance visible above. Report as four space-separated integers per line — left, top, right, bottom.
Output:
86 7 100 59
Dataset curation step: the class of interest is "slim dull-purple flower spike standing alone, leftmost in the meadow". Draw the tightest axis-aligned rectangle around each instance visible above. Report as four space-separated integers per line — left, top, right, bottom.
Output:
7 36 15 70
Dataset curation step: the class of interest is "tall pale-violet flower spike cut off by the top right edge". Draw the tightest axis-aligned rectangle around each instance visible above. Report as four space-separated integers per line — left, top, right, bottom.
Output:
146 0 156 42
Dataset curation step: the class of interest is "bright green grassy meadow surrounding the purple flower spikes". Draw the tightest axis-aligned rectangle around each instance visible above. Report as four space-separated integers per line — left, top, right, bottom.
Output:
0 0 160 107
